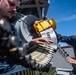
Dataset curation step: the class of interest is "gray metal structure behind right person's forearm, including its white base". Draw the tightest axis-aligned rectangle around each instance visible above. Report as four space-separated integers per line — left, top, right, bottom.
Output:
52 46 75 75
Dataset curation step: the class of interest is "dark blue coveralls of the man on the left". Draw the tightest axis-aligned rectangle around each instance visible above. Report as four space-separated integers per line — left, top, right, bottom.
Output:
0 25 26 75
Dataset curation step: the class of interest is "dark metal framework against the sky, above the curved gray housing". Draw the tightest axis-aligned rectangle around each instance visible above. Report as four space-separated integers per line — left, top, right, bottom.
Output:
18 0 50 19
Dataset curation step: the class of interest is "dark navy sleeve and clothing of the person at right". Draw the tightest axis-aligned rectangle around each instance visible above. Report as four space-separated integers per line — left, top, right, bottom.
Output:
57 34 76 74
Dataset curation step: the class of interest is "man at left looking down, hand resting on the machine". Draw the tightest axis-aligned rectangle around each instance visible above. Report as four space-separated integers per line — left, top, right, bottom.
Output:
0 0 51 75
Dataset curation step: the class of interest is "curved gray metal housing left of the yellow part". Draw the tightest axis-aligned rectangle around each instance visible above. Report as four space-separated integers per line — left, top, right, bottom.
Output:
15 15 38 42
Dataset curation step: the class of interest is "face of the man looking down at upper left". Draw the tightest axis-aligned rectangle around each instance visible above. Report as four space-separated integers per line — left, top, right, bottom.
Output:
0 0 20 18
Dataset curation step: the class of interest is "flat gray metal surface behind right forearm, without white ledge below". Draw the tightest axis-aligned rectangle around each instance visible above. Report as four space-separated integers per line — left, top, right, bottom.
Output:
52 46 75 69
